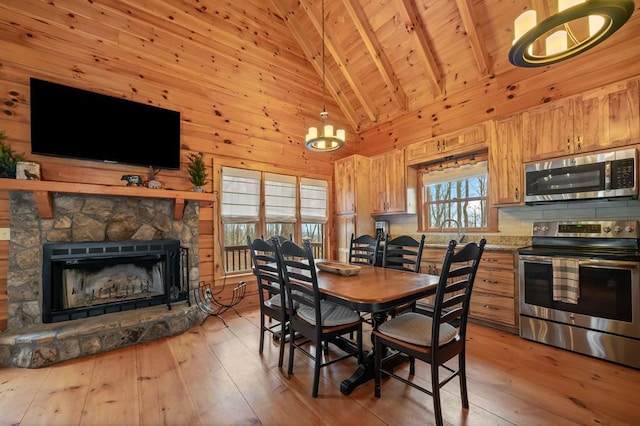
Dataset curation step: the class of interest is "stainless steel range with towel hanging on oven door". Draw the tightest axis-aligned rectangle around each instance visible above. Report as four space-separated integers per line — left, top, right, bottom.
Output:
518 221 640 368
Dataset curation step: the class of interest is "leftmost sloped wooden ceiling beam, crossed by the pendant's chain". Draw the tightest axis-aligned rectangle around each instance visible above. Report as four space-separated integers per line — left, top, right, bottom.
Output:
271 0 360 133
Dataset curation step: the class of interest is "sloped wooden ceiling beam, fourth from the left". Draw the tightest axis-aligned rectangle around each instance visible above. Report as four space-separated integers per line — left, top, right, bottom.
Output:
395 0 443 96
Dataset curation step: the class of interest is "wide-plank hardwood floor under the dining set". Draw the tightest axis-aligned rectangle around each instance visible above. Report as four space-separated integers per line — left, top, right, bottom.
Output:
0 311 640 426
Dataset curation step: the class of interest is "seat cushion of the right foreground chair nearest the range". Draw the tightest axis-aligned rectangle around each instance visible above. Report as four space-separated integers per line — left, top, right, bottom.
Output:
378 312 458 346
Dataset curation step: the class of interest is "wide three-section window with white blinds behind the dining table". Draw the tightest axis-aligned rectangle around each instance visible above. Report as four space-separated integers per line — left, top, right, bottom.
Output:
221 167 328 272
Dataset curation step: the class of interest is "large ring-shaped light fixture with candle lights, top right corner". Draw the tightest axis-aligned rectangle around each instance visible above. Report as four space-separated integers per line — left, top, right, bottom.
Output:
509 0 635 67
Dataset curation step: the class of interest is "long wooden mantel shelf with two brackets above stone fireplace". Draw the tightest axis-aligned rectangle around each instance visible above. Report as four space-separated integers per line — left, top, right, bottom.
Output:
0 179 215 220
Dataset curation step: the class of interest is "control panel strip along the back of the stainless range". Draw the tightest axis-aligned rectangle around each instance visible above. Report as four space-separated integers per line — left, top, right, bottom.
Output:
531 220 640 238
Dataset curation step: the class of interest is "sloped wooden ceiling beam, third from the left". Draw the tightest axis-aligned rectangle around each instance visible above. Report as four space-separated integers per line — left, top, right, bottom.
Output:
343 0 409 111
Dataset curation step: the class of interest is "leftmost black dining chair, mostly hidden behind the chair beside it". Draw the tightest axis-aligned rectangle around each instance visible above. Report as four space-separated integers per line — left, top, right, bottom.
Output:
247 235 289 367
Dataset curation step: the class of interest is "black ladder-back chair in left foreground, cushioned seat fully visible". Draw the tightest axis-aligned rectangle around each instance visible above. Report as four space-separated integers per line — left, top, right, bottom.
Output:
275 240 363 398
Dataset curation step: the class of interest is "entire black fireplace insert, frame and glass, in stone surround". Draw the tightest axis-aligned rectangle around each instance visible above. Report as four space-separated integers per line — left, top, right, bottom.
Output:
42 240 189 323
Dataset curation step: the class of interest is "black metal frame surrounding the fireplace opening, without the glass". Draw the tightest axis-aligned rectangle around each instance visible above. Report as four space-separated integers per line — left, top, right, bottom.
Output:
42 239 190 323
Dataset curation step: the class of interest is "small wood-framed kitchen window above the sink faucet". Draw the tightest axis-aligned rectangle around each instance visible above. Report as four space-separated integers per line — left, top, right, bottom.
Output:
422 161 492 230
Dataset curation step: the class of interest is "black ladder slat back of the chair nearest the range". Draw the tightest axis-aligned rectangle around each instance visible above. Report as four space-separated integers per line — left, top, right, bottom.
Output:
431 238 486 342
